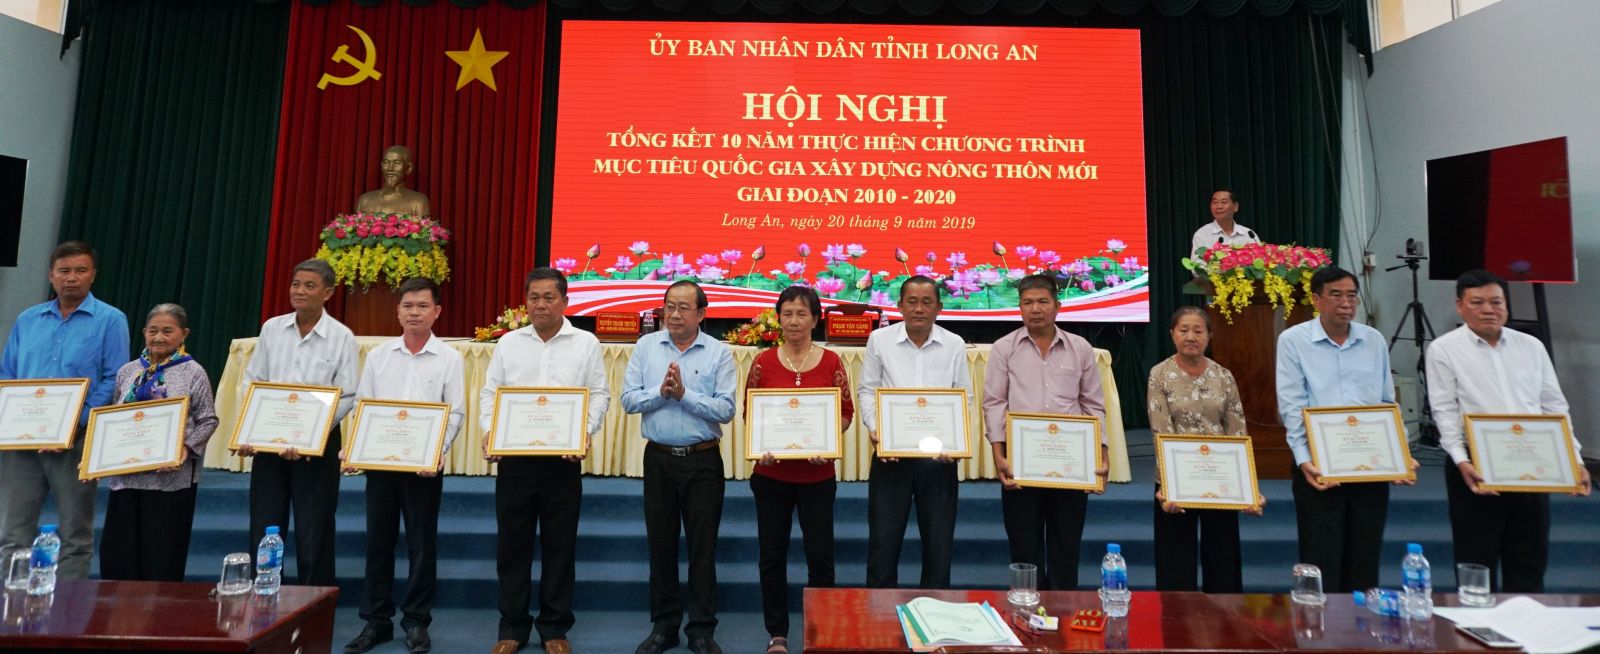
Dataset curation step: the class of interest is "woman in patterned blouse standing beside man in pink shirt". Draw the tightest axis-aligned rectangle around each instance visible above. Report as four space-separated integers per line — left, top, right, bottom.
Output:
1147 307 1266 593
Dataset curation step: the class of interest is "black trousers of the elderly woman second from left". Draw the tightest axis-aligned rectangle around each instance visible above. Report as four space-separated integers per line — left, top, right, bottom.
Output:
101 486 195 582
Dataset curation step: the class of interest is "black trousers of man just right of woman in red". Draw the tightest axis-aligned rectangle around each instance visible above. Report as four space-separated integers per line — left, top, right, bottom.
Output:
867 459 957 588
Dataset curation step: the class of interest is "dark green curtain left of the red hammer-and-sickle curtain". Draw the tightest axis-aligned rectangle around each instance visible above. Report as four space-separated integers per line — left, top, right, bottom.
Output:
61 0 288 379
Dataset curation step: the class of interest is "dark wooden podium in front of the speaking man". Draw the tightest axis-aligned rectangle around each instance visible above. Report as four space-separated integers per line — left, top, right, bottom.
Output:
1186 283 1312 480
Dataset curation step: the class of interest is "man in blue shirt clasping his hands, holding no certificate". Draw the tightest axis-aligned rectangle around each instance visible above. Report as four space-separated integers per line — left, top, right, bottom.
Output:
622 280 739 654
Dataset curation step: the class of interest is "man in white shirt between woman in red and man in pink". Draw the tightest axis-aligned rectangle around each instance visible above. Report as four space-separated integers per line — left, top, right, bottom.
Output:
856 275 973 588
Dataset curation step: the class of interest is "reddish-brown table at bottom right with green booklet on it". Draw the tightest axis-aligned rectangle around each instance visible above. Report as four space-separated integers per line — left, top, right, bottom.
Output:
805 588 1600 654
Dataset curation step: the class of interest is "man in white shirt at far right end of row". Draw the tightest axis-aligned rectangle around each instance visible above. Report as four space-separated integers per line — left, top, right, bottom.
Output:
1427 270 1589 593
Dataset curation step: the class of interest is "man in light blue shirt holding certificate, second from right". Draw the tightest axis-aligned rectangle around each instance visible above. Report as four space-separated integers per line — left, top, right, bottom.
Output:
1277 265 1416 593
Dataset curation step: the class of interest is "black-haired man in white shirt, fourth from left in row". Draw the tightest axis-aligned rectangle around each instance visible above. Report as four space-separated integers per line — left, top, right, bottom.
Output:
341 277 467 654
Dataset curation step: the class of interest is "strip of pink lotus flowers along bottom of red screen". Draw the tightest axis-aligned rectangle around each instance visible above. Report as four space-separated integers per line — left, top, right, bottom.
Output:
552 238 1150 309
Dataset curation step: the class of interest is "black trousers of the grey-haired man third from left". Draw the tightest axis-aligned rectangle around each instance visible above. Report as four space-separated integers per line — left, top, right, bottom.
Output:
246 425 344 585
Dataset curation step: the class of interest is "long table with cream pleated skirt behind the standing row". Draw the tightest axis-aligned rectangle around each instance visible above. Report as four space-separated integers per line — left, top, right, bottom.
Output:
205 336 1133 481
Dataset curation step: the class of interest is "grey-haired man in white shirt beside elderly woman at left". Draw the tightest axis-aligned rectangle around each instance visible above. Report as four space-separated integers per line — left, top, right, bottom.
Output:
238 259 360 585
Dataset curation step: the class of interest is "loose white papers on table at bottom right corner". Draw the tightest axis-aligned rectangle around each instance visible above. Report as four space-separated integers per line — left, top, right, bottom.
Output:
1434 596 1600 654
